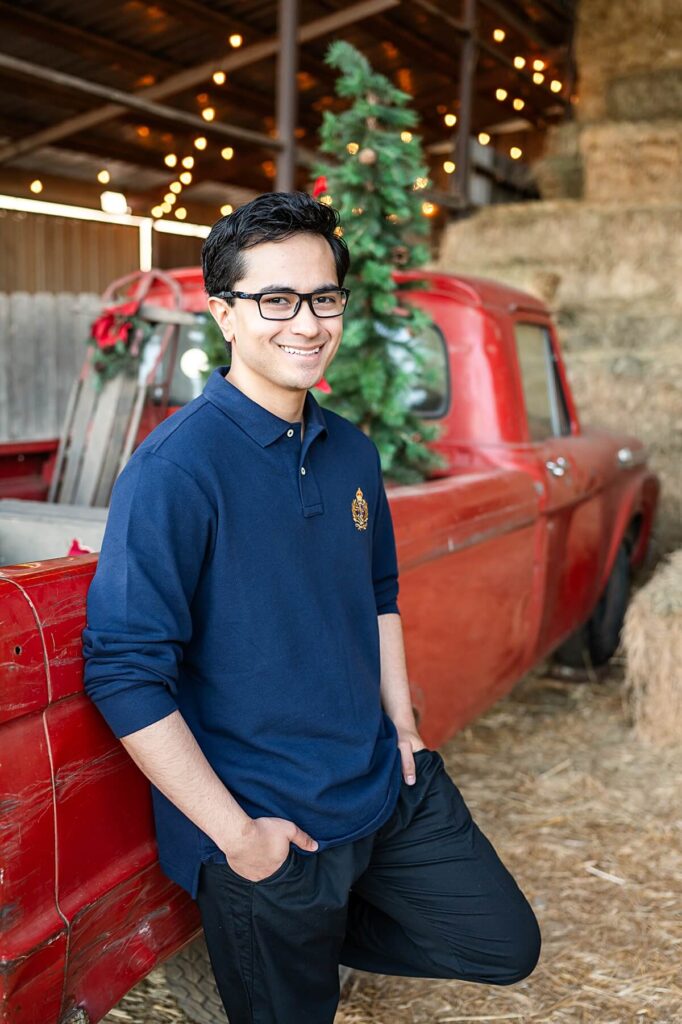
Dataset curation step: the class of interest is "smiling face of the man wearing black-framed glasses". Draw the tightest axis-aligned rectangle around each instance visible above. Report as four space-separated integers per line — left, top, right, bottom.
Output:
209 232 343 390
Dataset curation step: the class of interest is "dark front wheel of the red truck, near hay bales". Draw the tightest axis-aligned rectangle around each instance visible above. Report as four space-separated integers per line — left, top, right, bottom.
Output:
554 542 630 669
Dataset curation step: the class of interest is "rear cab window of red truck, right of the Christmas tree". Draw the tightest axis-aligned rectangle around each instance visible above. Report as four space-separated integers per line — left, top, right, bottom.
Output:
377 324 450 420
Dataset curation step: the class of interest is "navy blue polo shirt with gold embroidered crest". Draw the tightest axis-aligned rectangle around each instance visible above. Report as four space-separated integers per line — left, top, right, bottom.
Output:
83 367 401 896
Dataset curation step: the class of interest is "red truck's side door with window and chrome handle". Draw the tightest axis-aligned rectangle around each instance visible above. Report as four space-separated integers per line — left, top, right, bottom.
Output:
514 312 604 654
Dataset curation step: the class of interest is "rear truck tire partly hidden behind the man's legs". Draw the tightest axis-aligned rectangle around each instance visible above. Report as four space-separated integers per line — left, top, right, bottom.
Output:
164 935 352 1024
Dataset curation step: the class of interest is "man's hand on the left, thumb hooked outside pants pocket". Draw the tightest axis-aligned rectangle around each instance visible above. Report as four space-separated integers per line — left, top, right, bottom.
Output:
222 818 317 882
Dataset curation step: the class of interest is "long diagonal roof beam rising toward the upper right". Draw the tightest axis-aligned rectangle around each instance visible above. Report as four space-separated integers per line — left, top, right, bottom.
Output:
0 0 399 163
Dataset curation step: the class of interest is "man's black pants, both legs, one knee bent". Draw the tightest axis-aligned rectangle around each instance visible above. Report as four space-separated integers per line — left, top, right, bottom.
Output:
197 750 540 1024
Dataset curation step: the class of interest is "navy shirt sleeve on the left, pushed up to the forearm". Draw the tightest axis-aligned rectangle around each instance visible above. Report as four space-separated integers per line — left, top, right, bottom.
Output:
83 453 214 737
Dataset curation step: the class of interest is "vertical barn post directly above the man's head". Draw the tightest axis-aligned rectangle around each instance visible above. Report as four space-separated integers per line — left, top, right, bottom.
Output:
275 0 298 191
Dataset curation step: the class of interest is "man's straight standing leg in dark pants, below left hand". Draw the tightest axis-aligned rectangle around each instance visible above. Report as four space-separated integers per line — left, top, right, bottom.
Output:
197 836 373 1024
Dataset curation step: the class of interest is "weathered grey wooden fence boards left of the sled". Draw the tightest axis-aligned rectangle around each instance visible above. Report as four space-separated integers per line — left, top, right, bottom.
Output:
0 292 101 441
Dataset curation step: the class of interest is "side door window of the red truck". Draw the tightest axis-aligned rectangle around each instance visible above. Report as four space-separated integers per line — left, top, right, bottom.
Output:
514 324 570 441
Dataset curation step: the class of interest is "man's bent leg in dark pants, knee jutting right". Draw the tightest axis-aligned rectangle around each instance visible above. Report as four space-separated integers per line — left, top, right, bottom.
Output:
340 750 540 985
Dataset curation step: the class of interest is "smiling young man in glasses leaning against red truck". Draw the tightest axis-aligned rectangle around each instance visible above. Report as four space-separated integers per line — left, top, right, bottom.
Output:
84 193 540 1024
